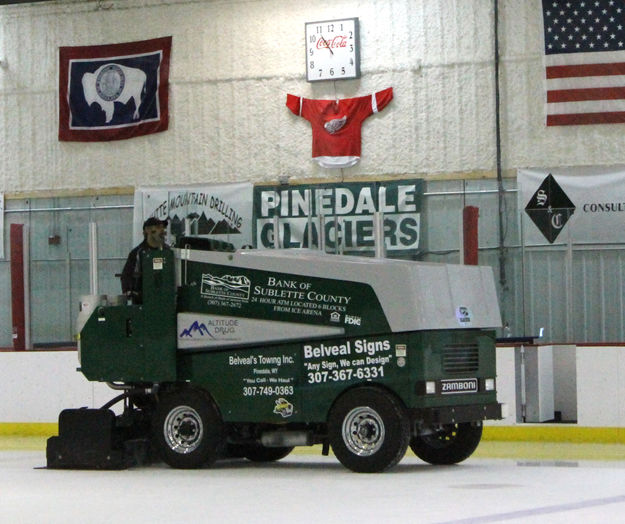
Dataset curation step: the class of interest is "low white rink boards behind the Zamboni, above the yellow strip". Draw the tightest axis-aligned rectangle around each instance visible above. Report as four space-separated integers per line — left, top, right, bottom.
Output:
0 345 625 427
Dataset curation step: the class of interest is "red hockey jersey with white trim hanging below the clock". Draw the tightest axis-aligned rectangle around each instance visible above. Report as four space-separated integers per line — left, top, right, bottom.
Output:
286 87 393 167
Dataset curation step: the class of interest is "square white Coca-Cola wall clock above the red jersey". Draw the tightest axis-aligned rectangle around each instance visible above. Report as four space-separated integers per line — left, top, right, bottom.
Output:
306 18 360 82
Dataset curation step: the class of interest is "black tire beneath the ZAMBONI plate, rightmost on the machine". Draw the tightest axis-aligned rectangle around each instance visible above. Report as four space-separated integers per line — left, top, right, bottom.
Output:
410 422 482 465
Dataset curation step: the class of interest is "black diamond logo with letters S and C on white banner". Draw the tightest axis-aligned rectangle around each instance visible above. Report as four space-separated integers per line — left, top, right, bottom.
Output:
525 173 575 244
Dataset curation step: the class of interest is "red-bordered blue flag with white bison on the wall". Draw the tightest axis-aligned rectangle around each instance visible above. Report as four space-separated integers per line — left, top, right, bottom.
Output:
59 36 171 142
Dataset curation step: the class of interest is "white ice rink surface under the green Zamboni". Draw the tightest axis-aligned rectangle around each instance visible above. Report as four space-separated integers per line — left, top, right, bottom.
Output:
0 450 625 524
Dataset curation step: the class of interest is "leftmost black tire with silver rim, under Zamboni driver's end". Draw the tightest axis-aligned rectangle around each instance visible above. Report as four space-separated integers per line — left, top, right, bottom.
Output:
152 389 223 469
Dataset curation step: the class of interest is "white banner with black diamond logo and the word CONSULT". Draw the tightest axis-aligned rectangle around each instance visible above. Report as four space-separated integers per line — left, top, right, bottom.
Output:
518 166 625 245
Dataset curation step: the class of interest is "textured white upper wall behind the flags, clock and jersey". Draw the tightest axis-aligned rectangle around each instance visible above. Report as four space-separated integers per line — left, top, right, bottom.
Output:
0 0 625 194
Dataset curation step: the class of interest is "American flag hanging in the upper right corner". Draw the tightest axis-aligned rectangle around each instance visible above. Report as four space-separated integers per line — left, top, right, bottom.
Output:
542 0 625 126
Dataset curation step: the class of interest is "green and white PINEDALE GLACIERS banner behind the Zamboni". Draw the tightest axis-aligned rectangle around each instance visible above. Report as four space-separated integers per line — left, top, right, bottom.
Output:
254 180 423 254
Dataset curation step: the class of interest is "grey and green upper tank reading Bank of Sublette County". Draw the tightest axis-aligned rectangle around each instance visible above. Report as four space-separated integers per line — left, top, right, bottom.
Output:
175 249 501 348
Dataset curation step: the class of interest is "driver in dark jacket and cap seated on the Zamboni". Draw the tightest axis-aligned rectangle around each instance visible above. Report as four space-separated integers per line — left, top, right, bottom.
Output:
121 217 169 304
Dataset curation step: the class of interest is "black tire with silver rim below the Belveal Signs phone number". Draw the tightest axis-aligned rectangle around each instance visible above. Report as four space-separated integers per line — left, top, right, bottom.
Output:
328 387 410 473
